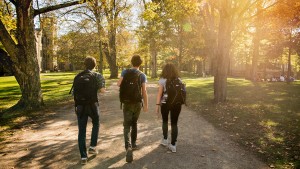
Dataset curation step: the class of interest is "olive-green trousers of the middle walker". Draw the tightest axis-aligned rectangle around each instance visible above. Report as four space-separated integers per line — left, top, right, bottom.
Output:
123 103 142 149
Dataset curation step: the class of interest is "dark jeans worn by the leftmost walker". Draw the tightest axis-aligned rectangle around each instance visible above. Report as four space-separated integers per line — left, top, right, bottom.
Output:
76 103 100 158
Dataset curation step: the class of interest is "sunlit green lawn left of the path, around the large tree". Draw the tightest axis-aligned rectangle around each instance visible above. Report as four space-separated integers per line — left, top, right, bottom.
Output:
0 71 116 141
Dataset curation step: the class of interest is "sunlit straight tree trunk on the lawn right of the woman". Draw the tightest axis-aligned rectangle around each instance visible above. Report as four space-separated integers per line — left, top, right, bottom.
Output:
214 0 232 103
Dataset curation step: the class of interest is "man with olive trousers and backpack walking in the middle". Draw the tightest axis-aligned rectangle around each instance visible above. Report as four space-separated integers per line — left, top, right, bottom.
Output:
117 55 148 162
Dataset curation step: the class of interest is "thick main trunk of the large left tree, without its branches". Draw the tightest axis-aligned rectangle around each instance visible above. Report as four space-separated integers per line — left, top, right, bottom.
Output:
13 1 44 109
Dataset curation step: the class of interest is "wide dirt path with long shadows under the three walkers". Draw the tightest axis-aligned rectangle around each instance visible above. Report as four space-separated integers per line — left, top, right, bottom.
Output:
0 84 268 169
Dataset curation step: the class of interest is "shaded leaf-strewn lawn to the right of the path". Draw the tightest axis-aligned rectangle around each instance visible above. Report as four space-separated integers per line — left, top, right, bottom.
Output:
185 78 300 168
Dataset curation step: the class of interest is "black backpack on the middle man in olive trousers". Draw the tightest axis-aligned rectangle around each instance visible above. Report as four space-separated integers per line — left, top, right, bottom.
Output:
119 69 142 103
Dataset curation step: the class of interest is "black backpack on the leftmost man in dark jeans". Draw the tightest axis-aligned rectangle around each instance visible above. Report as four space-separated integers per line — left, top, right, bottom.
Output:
70 71 98 106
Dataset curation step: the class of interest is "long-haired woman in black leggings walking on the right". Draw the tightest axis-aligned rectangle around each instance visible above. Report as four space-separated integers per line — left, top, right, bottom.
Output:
156 63 185 153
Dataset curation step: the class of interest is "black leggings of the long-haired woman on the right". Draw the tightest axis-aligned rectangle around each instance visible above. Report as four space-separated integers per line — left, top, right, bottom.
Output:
161 104 181 145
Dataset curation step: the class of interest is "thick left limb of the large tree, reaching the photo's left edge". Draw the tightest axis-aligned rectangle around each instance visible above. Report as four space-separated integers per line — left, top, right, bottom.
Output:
0 19 18 60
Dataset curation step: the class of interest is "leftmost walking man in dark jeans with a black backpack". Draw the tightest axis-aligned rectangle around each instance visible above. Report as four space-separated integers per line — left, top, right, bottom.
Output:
71 57 105 165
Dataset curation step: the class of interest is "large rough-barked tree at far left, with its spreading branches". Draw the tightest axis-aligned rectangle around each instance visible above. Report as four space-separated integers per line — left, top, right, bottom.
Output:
0 0 85 109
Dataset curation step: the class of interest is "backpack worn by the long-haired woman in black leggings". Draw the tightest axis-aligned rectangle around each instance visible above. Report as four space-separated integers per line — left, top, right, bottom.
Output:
166 78 186 109
